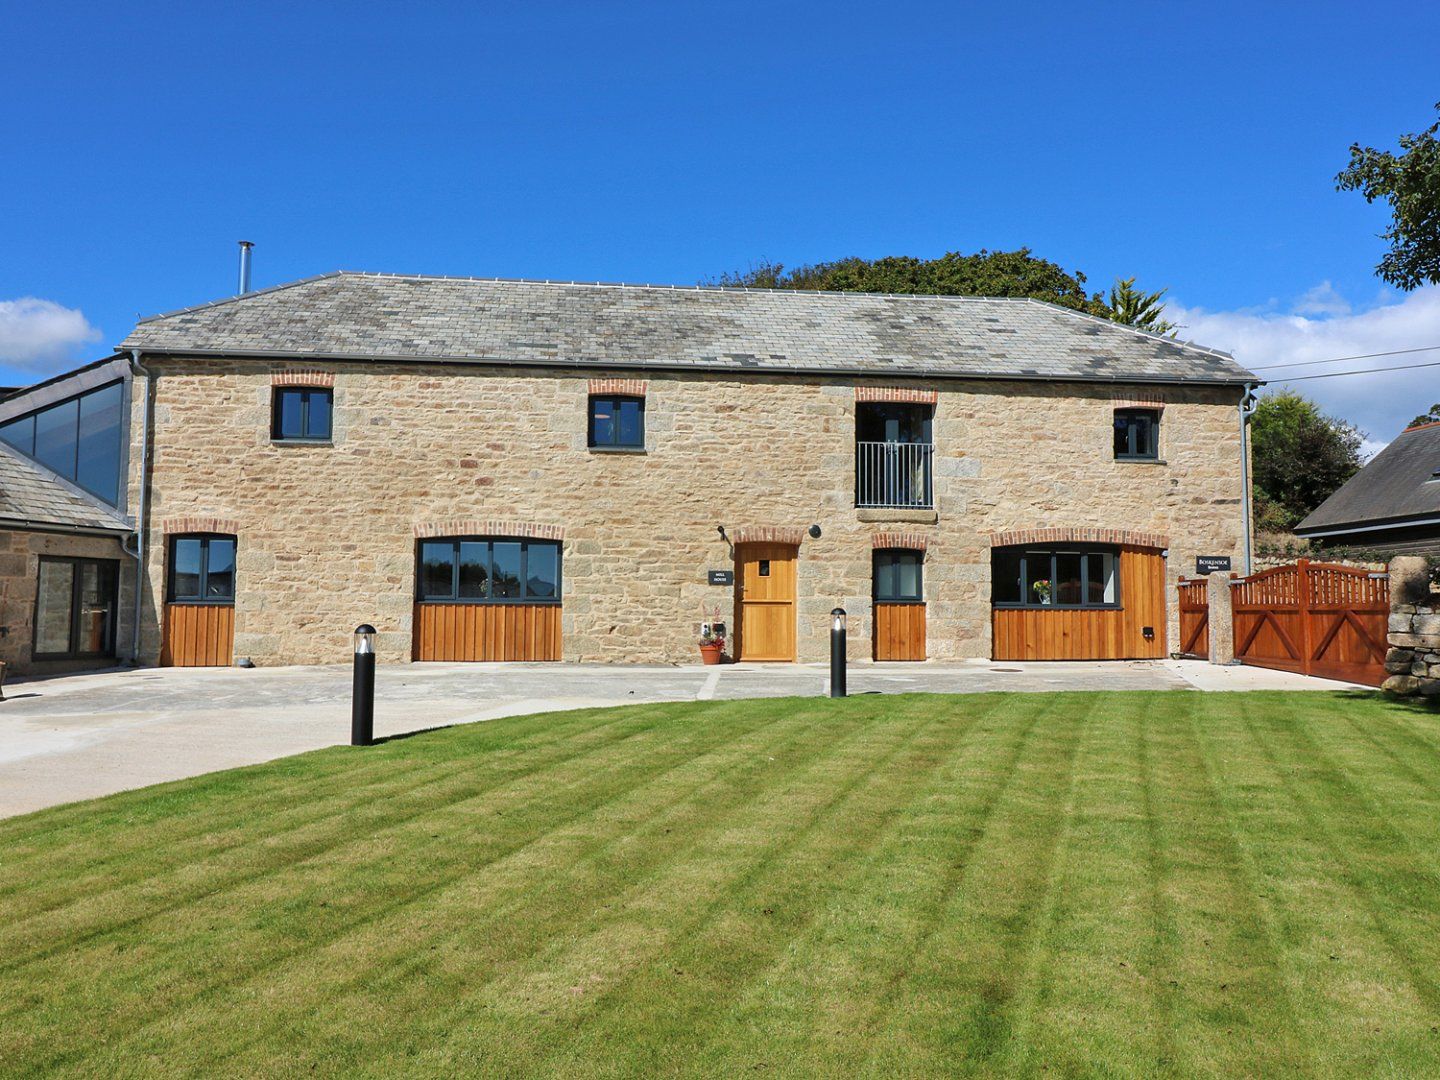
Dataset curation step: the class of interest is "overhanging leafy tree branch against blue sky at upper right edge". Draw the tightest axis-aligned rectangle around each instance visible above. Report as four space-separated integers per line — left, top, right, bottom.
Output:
1335 104 1440 291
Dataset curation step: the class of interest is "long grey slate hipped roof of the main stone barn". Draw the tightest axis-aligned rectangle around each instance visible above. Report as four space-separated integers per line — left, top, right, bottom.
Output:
120 272 1259 383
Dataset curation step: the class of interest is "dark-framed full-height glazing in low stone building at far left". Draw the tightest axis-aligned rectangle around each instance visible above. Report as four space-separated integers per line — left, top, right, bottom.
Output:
33 556 120 660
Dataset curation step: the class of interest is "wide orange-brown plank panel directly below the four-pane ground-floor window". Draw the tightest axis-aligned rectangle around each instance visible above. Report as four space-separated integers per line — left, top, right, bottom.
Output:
412 603 560 661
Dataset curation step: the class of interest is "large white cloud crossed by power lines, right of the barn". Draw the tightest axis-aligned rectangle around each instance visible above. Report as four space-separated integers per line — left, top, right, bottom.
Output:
1165 281 1440 454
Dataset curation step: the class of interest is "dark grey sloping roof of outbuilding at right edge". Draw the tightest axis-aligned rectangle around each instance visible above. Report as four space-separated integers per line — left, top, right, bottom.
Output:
1295 423 1440 536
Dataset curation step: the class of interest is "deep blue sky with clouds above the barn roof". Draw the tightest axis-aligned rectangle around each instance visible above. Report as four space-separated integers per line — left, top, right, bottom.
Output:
0 0 1440 441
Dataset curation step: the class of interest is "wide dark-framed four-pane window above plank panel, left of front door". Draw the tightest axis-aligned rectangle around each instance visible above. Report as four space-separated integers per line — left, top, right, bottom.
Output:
416 537 560 603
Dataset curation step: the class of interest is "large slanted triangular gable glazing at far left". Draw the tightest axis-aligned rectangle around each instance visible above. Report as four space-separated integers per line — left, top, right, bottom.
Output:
0 382 125 507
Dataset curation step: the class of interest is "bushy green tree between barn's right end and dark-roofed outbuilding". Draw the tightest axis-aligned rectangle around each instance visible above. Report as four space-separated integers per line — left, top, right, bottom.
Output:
1250 390 1365 531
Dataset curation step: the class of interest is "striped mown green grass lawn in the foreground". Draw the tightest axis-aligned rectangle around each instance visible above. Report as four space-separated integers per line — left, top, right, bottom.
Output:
0 693 1440 1077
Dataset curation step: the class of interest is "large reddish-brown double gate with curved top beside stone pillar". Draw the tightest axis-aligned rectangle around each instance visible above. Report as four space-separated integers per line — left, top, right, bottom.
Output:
1231 559 1390 687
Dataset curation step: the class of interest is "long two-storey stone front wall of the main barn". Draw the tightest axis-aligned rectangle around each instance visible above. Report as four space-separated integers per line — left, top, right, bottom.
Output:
131 357 1243 664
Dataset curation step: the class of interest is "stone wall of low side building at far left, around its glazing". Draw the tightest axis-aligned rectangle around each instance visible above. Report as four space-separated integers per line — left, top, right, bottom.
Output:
0 528 135 675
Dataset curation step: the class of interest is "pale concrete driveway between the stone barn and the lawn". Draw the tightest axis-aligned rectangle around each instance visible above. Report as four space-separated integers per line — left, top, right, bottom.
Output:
0 661 1365 816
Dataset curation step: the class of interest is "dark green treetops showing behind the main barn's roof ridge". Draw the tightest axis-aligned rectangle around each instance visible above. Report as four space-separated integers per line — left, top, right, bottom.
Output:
716 248 1110 318
